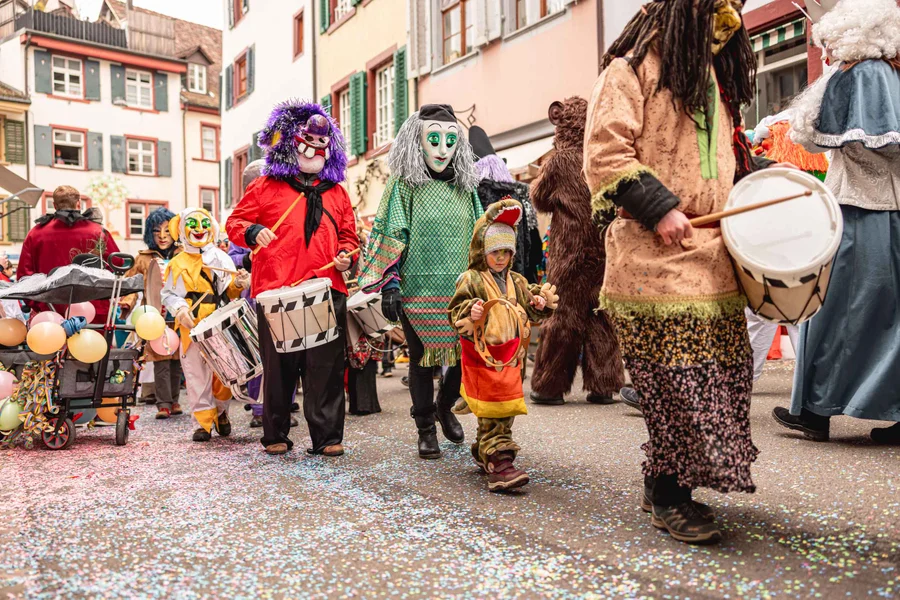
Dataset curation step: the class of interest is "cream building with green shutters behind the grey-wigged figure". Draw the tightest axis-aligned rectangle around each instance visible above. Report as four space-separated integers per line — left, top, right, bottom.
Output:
315 0 415 217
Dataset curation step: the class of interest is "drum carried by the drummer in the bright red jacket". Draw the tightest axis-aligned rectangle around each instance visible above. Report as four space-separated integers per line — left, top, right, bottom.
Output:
256 277 338 354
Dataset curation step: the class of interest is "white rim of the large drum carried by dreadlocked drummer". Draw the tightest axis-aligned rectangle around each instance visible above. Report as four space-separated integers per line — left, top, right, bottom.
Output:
722 167 844 281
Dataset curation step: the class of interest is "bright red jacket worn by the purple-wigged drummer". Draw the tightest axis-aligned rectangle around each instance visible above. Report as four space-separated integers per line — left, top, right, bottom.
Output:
225 177 359 298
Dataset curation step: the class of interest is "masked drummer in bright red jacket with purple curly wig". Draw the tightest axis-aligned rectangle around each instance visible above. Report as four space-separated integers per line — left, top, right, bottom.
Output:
225 101 359 456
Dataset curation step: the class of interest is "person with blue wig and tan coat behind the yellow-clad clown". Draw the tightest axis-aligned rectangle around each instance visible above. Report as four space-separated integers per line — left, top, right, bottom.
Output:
120 208 183 419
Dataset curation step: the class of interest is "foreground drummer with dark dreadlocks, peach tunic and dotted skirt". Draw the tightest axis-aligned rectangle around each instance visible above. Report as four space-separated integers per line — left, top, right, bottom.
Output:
584 0 788 543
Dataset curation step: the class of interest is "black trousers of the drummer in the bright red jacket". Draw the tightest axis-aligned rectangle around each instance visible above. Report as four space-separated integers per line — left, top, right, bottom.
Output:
256 290 347 454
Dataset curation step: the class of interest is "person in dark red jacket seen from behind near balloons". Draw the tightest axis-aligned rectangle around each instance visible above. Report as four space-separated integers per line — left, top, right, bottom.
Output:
17 185 119 323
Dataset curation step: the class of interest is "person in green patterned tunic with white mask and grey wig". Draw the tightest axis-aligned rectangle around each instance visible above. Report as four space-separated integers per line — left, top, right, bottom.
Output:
359 104 484 459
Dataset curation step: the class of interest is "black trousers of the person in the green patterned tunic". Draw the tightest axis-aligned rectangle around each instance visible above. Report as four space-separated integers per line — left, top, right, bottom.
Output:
400 314 462 425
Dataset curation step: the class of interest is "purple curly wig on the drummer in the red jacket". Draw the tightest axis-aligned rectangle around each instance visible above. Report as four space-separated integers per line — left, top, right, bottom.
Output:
257 100 347 183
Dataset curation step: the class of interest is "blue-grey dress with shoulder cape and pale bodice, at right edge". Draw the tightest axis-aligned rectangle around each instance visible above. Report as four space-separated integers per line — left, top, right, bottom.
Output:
791 60 900 421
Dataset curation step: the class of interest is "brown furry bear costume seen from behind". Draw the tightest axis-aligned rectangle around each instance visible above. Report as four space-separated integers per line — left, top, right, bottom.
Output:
531 96 625 404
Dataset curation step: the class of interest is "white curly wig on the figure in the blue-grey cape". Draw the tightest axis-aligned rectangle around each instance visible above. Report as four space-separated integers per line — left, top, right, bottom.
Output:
812 0 900 62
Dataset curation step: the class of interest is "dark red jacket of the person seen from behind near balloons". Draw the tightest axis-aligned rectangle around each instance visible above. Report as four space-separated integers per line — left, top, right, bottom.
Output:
16 219 119 324
